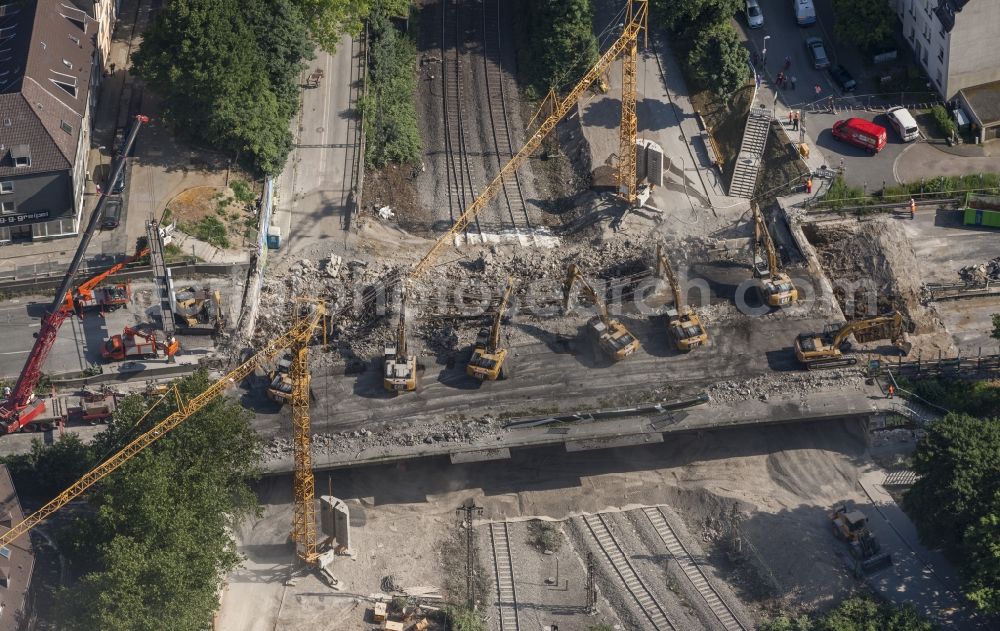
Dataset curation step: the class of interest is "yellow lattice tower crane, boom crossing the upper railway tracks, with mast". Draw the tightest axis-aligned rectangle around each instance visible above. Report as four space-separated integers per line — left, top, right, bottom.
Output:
410 0 649 278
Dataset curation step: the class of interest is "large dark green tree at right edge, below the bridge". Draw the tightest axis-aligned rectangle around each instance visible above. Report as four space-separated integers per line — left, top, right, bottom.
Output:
903 413 1000 614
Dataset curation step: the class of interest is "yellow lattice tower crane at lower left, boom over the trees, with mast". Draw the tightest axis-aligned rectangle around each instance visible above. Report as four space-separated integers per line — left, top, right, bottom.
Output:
0 304 326 564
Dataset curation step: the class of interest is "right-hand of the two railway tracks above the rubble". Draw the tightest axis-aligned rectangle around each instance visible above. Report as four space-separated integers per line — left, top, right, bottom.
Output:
483 0 531 245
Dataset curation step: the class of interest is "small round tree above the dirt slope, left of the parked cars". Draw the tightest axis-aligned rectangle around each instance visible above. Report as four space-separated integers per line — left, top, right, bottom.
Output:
688 22 749 96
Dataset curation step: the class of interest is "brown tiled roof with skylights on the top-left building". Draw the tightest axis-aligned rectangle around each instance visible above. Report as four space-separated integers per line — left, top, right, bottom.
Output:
0 0 97 177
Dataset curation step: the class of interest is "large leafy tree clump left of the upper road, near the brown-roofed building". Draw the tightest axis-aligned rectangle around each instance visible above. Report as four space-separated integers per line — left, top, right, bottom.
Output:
133 0 312 174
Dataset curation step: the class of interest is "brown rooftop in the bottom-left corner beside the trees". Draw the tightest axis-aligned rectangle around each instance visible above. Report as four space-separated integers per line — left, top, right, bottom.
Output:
0 464 35 631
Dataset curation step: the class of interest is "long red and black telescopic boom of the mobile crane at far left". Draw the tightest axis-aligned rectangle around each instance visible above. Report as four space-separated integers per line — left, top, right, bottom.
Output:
0 115 149 434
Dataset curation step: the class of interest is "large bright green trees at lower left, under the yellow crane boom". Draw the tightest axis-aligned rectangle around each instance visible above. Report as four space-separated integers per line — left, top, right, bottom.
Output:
55 371 260 631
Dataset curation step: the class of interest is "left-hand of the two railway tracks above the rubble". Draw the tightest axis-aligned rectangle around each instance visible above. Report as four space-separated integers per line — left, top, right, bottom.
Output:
441 0 482 237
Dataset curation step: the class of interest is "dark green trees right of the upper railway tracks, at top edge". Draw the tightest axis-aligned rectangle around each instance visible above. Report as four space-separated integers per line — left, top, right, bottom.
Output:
515 0 598 93
